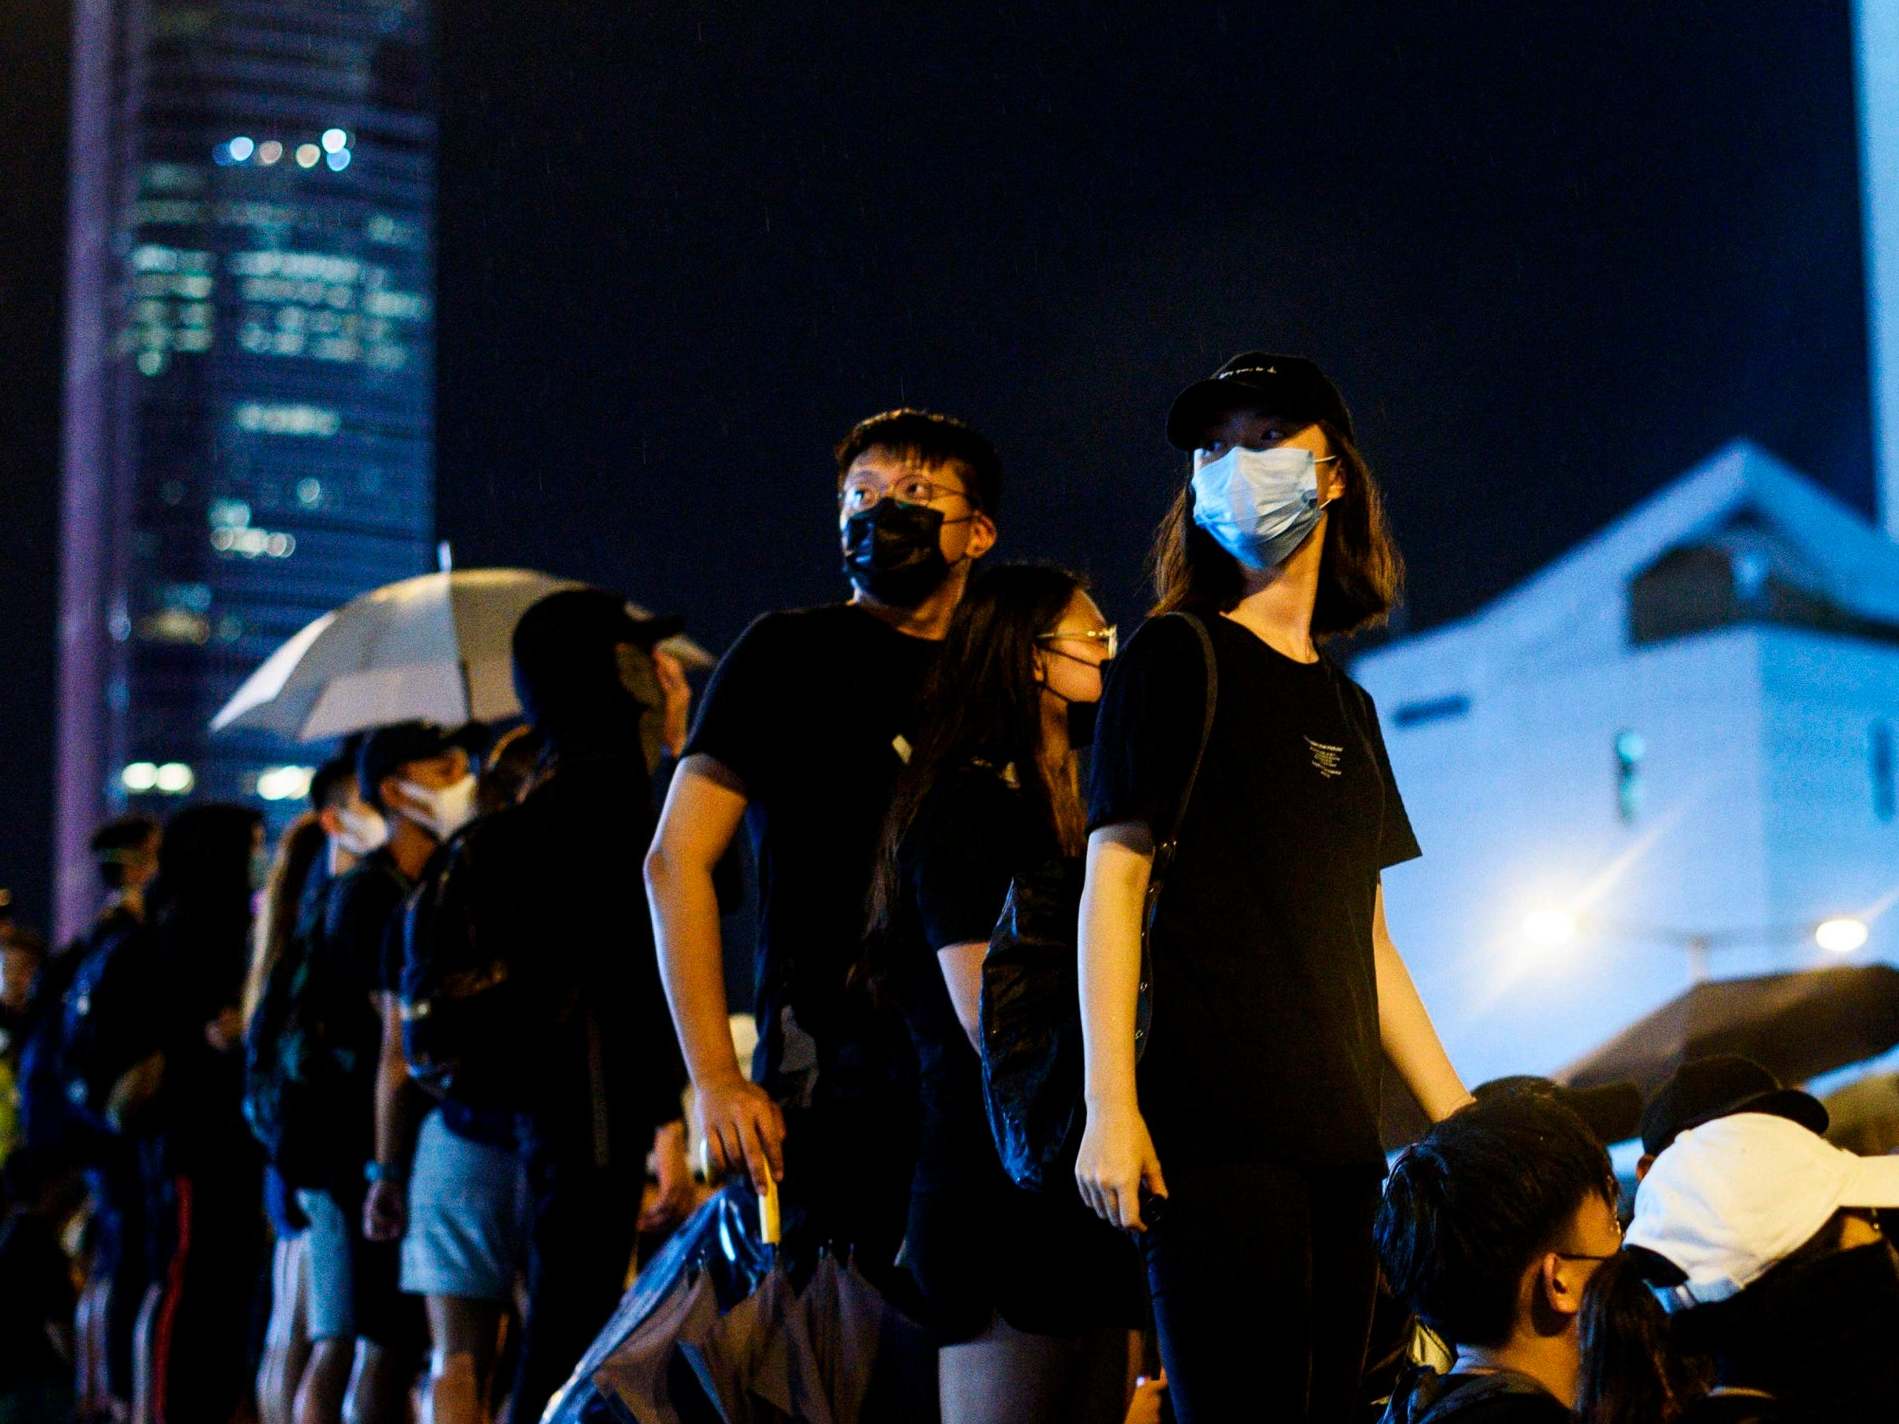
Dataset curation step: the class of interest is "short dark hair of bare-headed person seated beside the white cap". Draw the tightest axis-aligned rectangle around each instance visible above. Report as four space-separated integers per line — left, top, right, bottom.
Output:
1373 1094 1616 1346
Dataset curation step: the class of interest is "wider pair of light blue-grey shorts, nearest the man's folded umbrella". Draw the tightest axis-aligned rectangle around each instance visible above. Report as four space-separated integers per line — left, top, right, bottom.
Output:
403 1111 528 1302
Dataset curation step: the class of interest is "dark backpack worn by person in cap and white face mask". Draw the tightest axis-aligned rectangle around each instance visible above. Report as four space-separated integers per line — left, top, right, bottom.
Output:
243 880 376 1187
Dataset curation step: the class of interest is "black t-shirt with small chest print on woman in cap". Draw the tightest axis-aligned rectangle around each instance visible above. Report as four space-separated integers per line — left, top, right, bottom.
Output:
1088 615 1419 1166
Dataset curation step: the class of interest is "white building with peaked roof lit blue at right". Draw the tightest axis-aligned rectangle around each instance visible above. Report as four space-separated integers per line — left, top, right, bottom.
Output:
1354 442 1899 1082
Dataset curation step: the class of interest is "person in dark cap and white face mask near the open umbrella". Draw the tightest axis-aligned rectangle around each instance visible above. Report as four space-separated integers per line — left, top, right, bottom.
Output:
311 721 475 1424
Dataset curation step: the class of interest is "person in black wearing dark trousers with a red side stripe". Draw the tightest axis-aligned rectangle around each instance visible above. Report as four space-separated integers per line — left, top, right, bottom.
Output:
143 805 264 1420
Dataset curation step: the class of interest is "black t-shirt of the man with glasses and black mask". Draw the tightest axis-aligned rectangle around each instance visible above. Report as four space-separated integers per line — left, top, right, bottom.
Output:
686 604 938 1105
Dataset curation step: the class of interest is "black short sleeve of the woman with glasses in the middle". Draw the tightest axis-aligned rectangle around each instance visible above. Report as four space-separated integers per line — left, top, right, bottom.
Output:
902 769 1022 951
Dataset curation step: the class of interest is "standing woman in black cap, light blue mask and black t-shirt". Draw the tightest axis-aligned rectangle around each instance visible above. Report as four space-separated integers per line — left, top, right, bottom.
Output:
1075 351 1468 1420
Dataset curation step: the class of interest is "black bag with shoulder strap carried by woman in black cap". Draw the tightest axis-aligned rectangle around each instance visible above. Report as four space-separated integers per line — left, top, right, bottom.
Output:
982 613 1219 1190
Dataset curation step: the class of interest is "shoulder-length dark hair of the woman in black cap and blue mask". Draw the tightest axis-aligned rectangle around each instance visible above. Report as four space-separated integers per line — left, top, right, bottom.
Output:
1147 420 1405 638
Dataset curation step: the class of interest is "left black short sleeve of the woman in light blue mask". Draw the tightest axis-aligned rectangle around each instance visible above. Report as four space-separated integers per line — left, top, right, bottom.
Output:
1088 617 1206 839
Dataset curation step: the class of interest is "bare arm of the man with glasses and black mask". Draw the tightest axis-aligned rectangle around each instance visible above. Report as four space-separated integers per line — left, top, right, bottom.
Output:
646 756 784 1190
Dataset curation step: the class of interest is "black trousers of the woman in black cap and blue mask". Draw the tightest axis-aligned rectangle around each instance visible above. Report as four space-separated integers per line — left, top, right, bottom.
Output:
1141 1162 1379 1424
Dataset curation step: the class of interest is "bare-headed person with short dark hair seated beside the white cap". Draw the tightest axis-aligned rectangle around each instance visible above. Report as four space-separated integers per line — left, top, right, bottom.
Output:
1375 1092 1622 1424
